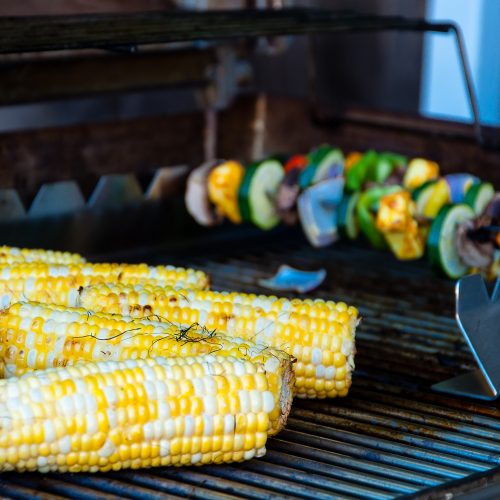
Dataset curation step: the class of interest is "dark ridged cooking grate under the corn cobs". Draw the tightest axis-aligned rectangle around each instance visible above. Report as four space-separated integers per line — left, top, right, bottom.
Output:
0 240 500 499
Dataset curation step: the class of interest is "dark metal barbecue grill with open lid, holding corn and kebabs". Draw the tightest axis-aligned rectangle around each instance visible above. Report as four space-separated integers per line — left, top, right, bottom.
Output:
0 4 500 500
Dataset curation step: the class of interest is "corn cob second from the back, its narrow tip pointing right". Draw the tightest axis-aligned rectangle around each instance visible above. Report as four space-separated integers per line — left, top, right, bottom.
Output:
0 262 209 308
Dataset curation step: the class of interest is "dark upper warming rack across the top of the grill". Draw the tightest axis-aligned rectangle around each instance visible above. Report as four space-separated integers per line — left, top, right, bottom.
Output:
0 8 458 53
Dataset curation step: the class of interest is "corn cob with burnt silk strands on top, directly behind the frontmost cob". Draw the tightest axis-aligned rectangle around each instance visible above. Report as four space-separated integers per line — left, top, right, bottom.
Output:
0 302 293 433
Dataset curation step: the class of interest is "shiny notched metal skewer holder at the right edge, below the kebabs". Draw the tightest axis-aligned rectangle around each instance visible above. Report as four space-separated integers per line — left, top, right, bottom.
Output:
432 274 500 401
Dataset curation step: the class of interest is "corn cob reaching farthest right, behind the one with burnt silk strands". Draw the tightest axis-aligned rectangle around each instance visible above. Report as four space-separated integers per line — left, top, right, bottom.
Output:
73 284 358 398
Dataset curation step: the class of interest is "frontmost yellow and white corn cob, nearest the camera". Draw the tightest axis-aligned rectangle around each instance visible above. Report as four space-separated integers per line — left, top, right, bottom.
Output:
0 354 290 472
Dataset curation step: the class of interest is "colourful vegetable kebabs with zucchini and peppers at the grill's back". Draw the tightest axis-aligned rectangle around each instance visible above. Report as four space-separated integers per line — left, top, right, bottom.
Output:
185 145 500 279
